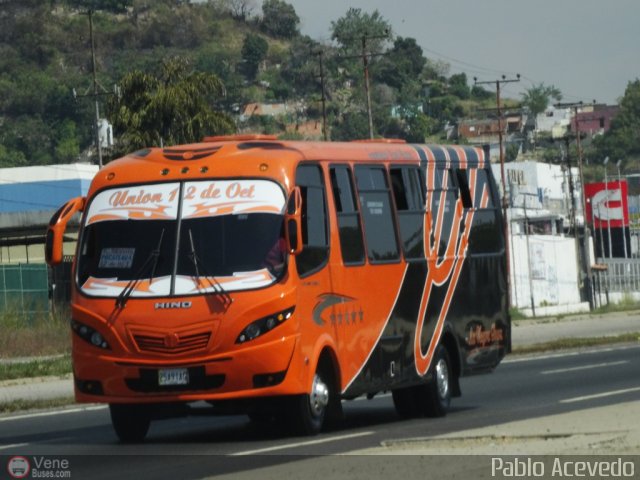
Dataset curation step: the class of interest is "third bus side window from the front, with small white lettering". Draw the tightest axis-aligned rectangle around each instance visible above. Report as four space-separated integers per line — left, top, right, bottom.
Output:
356 166 400 263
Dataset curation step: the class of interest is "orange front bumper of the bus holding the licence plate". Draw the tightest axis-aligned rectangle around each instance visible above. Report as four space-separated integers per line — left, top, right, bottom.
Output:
73 335 305 403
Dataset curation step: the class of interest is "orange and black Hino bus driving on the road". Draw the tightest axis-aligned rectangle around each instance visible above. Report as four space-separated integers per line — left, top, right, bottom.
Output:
46 135 510 441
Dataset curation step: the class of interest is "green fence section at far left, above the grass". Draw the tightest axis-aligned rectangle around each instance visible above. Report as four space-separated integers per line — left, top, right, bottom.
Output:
0 263 49 314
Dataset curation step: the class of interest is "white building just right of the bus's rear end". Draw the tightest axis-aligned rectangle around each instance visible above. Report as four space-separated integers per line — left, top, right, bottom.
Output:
492 161 592 315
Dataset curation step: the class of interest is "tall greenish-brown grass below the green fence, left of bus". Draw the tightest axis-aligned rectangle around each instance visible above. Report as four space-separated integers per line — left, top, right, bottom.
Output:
0 310 71 358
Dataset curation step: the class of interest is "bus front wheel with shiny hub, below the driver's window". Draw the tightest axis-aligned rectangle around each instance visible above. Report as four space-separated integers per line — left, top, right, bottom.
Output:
289 369 335 435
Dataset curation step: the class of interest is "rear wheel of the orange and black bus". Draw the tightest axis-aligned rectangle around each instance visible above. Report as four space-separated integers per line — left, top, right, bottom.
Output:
419 345 454 417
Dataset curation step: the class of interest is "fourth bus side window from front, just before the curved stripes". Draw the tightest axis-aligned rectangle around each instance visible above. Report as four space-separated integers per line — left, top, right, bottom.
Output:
389 167 425 260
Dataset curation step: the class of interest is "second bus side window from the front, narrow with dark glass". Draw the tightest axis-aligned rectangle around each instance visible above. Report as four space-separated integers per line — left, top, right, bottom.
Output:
330 165 364 265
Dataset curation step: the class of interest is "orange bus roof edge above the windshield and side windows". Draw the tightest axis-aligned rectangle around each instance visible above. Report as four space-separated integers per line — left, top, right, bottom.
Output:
90 135 488 194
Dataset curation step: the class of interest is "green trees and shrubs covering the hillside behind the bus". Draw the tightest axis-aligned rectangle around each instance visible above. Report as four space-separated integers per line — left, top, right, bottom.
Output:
0 0 640 172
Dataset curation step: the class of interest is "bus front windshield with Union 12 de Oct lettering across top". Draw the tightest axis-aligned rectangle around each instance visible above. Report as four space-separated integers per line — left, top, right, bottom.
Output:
77 179 287 297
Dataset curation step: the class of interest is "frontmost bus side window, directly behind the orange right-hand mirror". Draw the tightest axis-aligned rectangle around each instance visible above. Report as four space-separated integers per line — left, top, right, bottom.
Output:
296 164 329 277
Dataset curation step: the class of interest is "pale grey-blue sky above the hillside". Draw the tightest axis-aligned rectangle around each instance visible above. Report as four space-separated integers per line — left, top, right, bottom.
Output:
286 0 640 105
